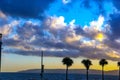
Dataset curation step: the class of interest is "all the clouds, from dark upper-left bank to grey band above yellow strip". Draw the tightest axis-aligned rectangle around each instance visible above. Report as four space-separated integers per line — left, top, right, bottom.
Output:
0 0 120 60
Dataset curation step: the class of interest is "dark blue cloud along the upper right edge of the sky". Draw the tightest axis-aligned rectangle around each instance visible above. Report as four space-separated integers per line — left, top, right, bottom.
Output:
106 0 120 39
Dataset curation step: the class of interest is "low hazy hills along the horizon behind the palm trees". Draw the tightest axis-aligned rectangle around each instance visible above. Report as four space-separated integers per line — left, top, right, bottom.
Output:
12 69 119 76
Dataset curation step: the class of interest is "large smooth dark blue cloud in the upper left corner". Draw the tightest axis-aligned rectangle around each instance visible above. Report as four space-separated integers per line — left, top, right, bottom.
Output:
0 0 54 18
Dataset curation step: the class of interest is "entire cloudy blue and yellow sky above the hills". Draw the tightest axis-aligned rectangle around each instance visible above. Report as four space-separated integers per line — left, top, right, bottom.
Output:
0 0 120 72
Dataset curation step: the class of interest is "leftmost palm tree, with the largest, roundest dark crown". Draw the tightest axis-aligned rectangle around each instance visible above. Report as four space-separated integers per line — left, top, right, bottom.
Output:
62 57 73 80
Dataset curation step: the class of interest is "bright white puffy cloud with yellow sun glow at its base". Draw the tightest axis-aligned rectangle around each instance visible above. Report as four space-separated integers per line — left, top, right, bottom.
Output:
83 15 106 41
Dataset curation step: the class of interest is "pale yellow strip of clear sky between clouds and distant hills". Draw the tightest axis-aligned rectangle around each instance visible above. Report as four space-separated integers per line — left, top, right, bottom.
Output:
2 54 118 72
